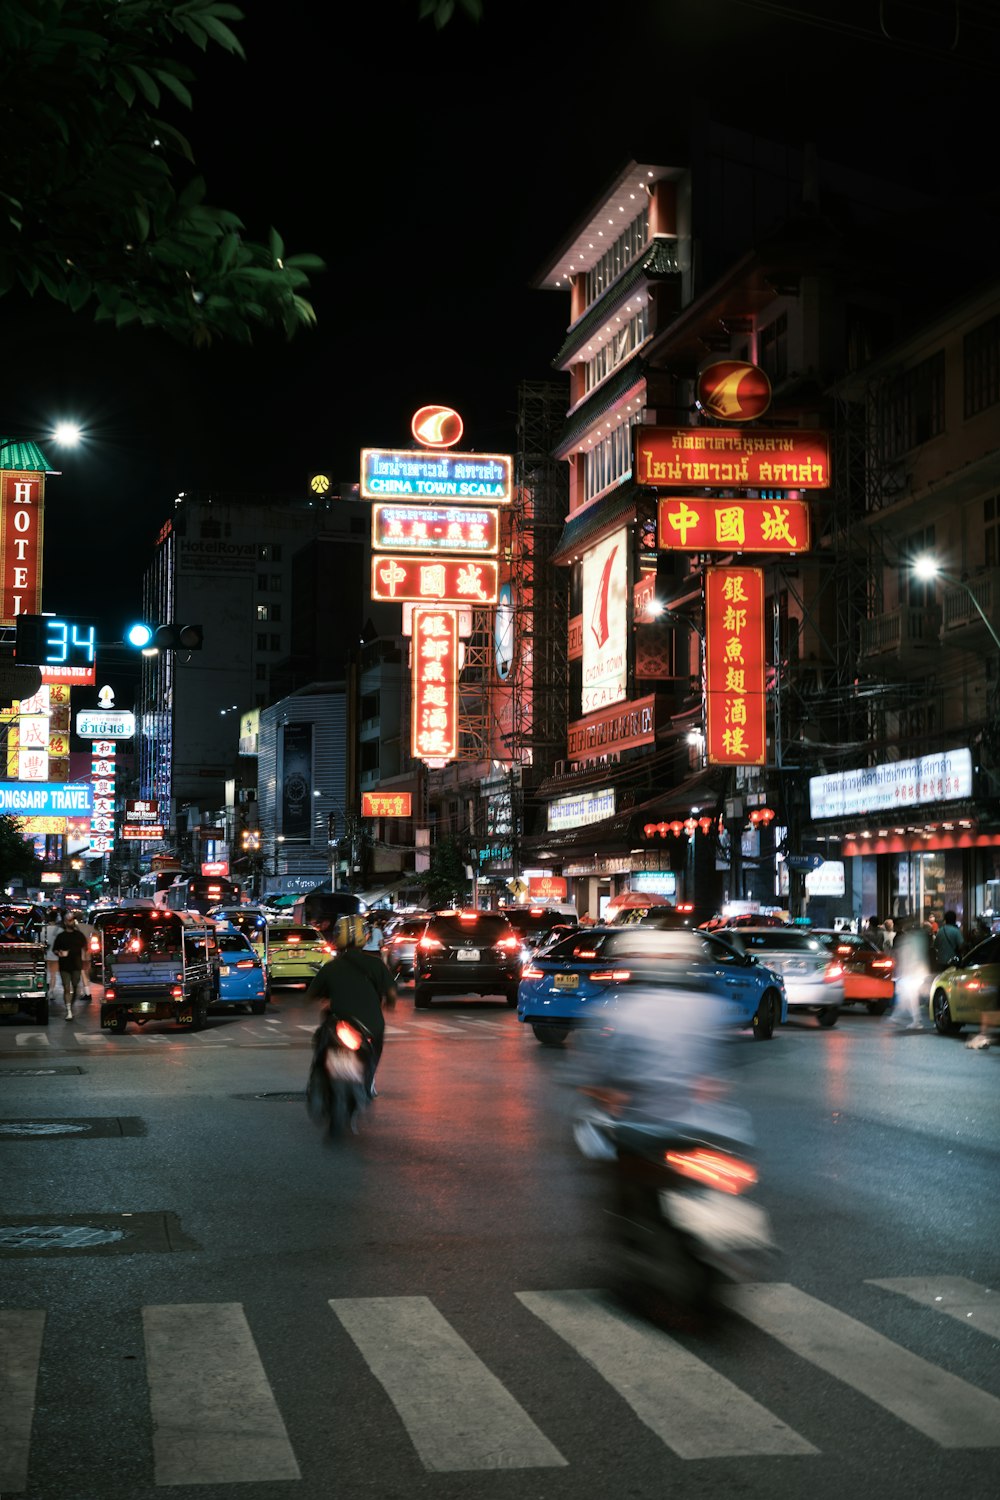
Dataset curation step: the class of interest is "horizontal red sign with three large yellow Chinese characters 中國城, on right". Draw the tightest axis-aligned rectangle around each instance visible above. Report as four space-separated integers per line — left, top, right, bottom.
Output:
657 495 810 552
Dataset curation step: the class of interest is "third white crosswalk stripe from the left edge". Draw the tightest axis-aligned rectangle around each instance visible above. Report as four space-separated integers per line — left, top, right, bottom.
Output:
330 1298 567 1473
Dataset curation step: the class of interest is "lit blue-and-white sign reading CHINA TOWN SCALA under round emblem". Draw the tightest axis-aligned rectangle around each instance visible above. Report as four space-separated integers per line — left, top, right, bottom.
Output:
361 449 514 506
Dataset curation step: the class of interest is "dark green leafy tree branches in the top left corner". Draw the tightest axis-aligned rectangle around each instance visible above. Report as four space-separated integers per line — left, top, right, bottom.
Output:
0 0 322 345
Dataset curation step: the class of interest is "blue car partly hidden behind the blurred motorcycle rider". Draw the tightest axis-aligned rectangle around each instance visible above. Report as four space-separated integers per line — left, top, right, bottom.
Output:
517 926 789 1046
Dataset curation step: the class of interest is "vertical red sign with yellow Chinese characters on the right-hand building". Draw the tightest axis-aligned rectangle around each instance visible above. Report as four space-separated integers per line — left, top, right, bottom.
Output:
705 567 768 765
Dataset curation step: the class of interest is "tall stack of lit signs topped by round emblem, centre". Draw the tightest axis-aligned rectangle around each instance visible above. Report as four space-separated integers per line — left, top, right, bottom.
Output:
360 405 514 762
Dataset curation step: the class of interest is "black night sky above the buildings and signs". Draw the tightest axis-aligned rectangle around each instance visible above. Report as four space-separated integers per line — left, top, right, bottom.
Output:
0 0 1000 633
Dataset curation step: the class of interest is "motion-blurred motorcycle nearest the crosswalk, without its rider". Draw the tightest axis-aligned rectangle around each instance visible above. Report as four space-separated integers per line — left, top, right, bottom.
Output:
574 1091 777 1314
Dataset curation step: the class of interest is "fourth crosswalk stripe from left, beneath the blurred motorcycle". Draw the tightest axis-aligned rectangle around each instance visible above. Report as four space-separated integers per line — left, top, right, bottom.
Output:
516 1292 817 1458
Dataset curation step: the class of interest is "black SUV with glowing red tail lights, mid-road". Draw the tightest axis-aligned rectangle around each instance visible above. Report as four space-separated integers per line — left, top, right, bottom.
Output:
414 912 520 1010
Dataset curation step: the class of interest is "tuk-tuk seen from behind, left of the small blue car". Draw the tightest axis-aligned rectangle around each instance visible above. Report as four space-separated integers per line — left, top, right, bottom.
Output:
91 905 219 1032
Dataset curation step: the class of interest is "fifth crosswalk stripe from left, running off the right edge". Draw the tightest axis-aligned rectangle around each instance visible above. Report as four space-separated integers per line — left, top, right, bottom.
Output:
727 1283 1000 1448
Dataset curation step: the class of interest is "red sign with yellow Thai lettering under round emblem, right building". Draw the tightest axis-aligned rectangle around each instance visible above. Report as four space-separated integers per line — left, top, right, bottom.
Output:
633 428 831 489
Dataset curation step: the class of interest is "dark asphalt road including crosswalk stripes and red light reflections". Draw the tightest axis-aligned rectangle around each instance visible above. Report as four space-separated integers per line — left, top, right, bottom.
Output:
0 996 1000 1500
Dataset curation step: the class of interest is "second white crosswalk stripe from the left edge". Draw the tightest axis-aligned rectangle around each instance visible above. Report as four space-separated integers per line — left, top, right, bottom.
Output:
142 1302 301 1485
